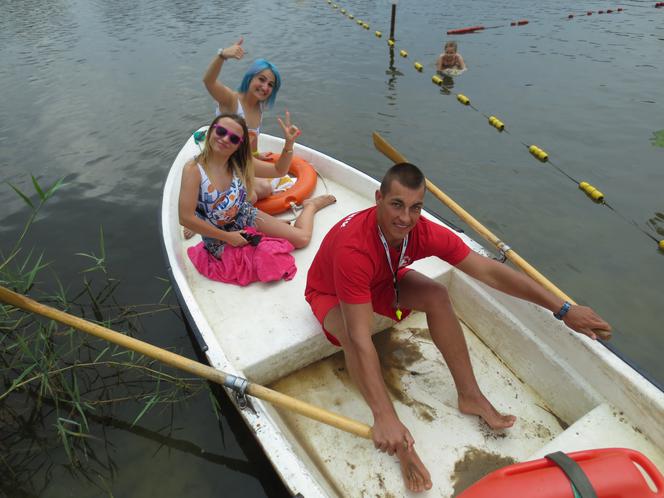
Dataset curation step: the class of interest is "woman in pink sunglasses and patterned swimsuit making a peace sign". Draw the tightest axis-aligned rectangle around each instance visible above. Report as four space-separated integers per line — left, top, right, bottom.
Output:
179 114 336 253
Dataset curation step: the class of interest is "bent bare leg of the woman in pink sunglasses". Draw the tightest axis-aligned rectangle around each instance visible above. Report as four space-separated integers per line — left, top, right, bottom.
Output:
256 195 336 249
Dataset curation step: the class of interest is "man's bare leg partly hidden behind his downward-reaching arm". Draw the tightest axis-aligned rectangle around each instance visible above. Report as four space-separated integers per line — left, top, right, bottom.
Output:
324 306 432 492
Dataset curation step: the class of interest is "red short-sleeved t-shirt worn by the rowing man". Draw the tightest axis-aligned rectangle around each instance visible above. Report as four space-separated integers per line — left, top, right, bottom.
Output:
305 206 470 304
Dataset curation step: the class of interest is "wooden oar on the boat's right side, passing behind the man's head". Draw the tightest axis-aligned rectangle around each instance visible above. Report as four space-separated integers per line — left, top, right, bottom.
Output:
373 131 611 340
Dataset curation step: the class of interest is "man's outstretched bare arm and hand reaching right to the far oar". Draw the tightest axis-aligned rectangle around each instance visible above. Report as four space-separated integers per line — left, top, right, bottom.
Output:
456 251 611 339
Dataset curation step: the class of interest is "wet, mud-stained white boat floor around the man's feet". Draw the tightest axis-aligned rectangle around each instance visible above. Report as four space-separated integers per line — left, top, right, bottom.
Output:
271 313 566 497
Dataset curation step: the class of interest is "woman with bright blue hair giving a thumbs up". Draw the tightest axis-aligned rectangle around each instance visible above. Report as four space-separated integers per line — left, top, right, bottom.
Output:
203 37 288 199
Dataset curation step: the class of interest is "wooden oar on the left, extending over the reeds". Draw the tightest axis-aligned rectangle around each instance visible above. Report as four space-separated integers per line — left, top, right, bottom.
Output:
0 286 371 439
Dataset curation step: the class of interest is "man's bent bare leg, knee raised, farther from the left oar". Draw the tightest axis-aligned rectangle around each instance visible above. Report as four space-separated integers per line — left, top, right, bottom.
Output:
399 271 516 429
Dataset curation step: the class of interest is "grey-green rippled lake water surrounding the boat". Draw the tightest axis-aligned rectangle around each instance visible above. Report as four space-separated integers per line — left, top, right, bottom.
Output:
0 0 664 497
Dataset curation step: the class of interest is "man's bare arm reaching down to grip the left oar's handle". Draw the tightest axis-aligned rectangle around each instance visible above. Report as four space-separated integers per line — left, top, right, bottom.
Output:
340 302 414 455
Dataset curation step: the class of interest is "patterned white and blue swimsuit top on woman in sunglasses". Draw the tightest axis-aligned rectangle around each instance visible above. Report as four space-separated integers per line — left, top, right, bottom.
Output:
196 164 258 258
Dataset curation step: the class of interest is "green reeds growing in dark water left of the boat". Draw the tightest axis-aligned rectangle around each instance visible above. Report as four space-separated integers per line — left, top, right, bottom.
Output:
0 176 221 496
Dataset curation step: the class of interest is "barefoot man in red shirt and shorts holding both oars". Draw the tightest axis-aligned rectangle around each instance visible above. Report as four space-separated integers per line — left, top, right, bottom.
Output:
305 163 611 491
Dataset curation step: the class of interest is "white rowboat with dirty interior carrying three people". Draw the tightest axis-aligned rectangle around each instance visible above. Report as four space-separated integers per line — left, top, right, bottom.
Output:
161 129 664 498
